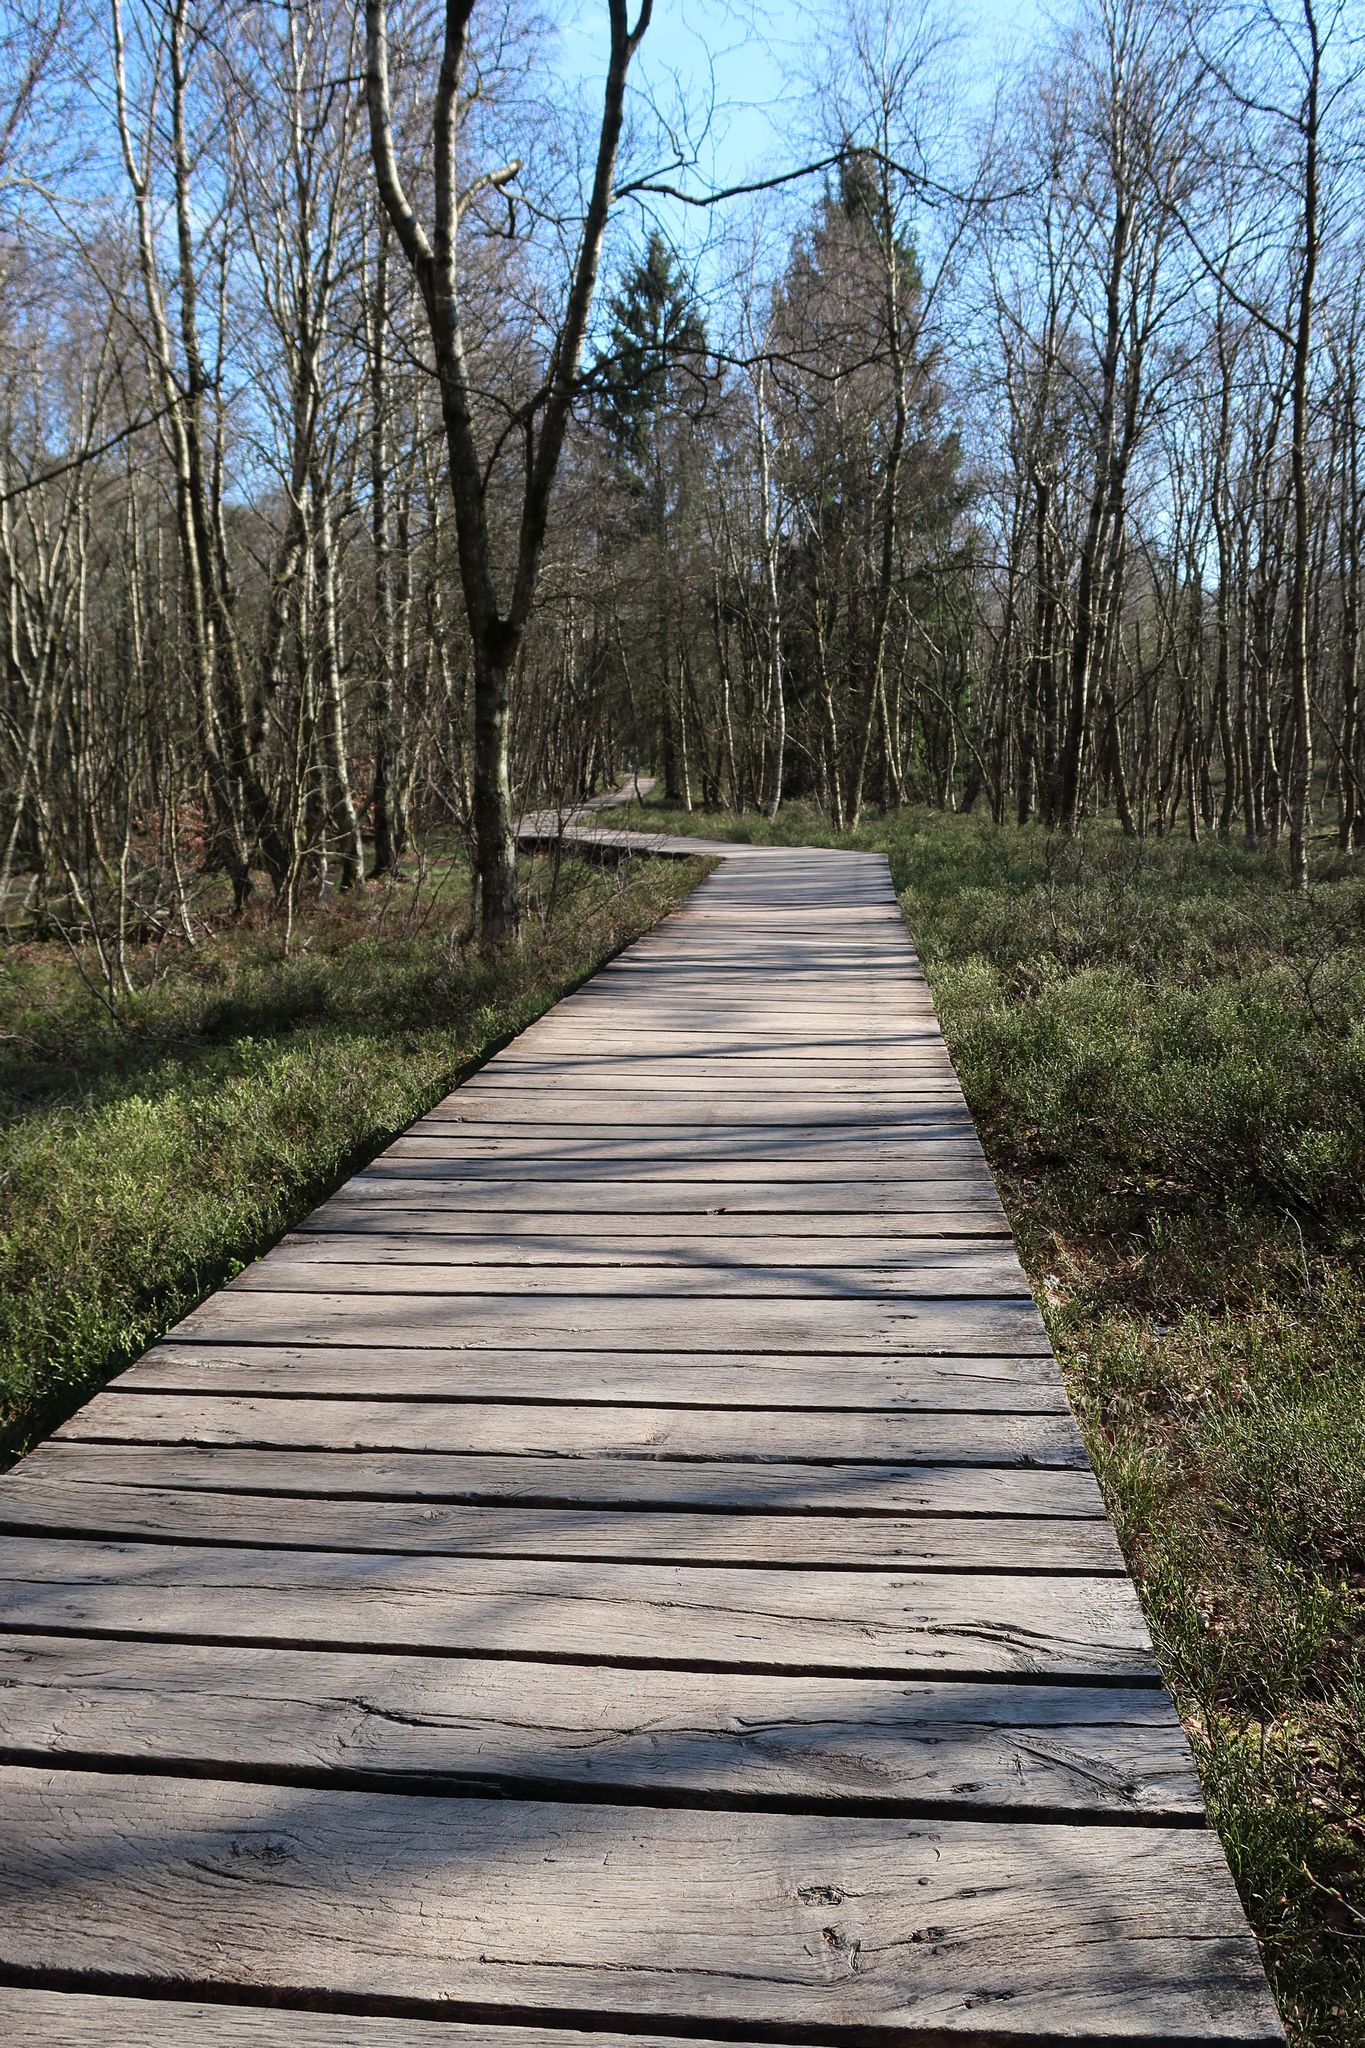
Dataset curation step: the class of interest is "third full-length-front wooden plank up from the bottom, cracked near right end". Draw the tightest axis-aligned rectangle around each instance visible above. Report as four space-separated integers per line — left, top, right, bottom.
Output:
0 1536 1156 1681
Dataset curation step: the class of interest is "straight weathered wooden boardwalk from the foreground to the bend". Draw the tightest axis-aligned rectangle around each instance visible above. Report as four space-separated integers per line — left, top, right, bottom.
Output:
0 848 1281 2048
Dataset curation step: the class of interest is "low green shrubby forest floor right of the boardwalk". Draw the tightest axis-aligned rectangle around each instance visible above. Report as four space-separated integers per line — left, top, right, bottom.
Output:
626 786 1365 2048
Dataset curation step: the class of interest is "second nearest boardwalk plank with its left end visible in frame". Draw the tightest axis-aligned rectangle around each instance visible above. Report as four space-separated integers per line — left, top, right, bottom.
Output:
55 1400 1087 1468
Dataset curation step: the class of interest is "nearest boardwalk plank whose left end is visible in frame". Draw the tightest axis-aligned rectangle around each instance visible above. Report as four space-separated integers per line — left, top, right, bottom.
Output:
23 1438 1105 1516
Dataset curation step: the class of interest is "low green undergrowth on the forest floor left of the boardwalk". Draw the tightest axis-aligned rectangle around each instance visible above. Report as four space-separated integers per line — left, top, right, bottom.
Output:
0 860 706 1464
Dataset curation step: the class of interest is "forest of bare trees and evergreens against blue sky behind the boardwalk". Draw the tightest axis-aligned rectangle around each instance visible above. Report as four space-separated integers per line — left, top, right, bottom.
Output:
0 0 1365 950
